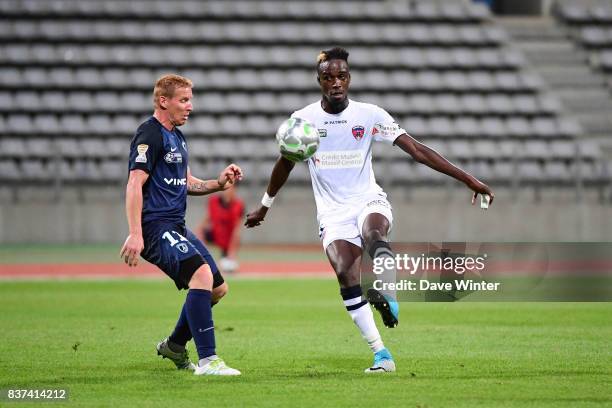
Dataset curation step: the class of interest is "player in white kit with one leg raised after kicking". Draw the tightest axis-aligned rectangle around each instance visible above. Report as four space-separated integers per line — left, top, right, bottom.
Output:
245 48 494 373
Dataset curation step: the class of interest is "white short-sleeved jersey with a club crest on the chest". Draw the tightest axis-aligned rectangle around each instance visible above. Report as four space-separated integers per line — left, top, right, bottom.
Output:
291 100 405 222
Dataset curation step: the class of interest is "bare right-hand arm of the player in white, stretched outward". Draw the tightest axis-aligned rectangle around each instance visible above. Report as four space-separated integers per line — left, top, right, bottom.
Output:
394 133 495 204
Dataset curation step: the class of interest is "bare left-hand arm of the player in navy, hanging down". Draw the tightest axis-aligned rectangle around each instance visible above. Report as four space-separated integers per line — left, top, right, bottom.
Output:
119 170 149 266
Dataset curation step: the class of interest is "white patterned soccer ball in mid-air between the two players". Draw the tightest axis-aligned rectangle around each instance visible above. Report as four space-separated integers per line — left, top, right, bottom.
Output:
276 118 319 162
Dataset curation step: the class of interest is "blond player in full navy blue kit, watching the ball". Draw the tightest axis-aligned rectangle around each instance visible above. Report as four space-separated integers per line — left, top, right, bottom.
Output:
121 75 242 375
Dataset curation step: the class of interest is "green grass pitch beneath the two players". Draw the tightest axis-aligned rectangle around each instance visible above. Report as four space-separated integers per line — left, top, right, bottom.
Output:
0 279 612 408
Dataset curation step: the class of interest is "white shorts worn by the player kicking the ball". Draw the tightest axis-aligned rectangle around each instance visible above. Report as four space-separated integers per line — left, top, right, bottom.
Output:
319 195 393 250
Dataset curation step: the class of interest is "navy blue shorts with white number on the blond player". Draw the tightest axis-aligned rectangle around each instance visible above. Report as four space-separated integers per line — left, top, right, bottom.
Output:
141 221 224 289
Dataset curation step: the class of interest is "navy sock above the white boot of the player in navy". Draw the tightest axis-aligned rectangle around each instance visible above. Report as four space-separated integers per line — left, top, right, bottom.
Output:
185 289 215 360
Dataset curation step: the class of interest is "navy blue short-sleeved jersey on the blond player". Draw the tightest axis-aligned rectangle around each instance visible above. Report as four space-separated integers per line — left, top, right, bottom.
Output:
129 116 187 224
